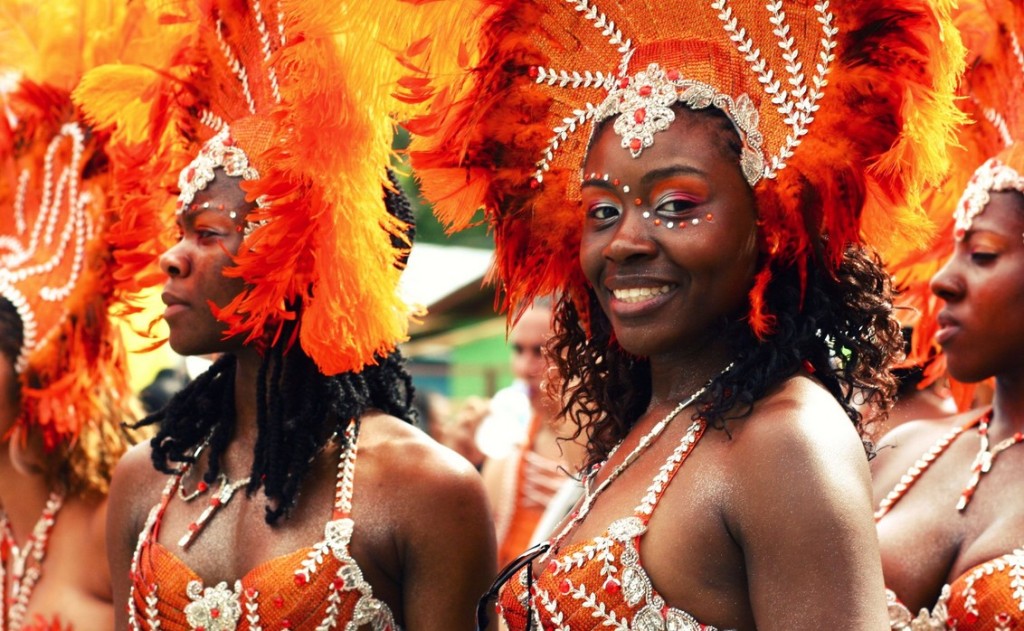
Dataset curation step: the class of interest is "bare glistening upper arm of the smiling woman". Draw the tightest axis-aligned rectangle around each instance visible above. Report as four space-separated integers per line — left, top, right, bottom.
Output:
733 403 888 631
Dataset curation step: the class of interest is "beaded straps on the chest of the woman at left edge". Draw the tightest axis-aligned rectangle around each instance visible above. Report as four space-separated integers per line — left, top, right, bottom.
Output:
0 492 65 631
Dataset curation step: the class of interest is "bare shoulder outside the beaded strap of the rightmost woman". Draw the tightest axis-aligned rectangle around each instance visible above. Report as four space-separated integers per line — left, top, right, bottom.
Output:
871 410 979 499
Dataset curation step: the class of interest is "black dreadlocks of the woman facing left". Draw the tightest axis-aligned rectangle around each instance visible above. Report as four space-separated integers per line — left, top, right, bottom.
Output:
137 172 415 524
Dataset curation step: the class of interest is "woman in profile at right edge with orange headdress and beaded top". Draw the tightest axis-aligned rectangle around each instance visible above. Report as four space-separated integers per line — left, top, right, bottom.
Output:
873 0 1024 631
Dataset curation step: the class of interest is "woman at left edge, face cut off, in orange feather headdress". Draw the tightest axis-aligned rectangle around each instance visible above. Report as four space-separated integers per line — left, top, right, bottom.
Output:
0 1 148 631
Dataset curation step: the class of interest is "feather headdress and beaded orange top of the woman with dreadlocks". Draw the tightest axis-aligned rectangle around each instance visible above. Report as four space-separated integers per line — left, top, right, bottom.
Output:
75 0 468 631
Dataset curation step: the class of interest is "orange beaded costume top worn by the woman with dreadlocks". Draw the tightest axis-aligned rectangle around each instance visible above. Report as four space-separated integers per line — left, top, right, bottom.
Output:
128 423 398 631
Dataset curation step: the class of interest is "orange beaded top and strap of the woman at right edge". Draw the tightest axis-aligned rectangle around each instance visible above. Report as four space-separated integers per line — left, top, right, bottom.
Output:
876 411 1024 631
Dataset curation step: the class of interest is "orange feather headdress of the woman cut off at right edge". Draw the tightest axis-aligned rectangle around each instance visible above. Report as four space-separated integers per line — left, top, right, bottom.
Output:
891 0 1024 409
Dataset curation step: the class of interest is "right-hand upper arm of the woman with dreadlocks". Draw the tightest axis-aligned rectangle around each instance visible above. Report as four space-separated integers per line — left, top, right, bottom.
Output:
402 446 497 631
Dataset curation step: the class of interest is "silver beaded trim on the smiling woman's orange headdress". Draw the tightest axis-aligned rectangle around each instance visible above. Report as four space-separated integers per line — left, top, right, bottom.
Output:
531 0 839 186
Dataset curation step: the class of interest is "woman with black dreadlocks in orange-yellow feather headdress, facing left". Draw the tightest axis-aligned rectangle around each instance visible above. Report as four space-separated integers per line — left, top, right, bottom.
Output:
76 0 496 631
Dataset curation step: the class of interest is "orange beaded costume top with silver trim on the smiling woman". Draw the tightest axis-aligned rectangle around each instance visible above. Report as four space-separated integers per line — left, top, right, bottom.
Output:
498 422 729 631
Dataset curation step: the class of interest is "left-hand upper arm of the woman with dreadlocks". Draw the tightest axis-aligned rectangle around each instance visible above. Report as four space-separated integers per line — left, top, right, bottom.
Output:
106 443 155 631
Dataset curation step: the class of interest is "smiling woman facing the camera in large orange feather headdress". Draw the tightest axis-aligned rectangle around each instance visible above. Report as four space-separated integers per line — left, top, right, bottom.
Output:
411 0 962 631
